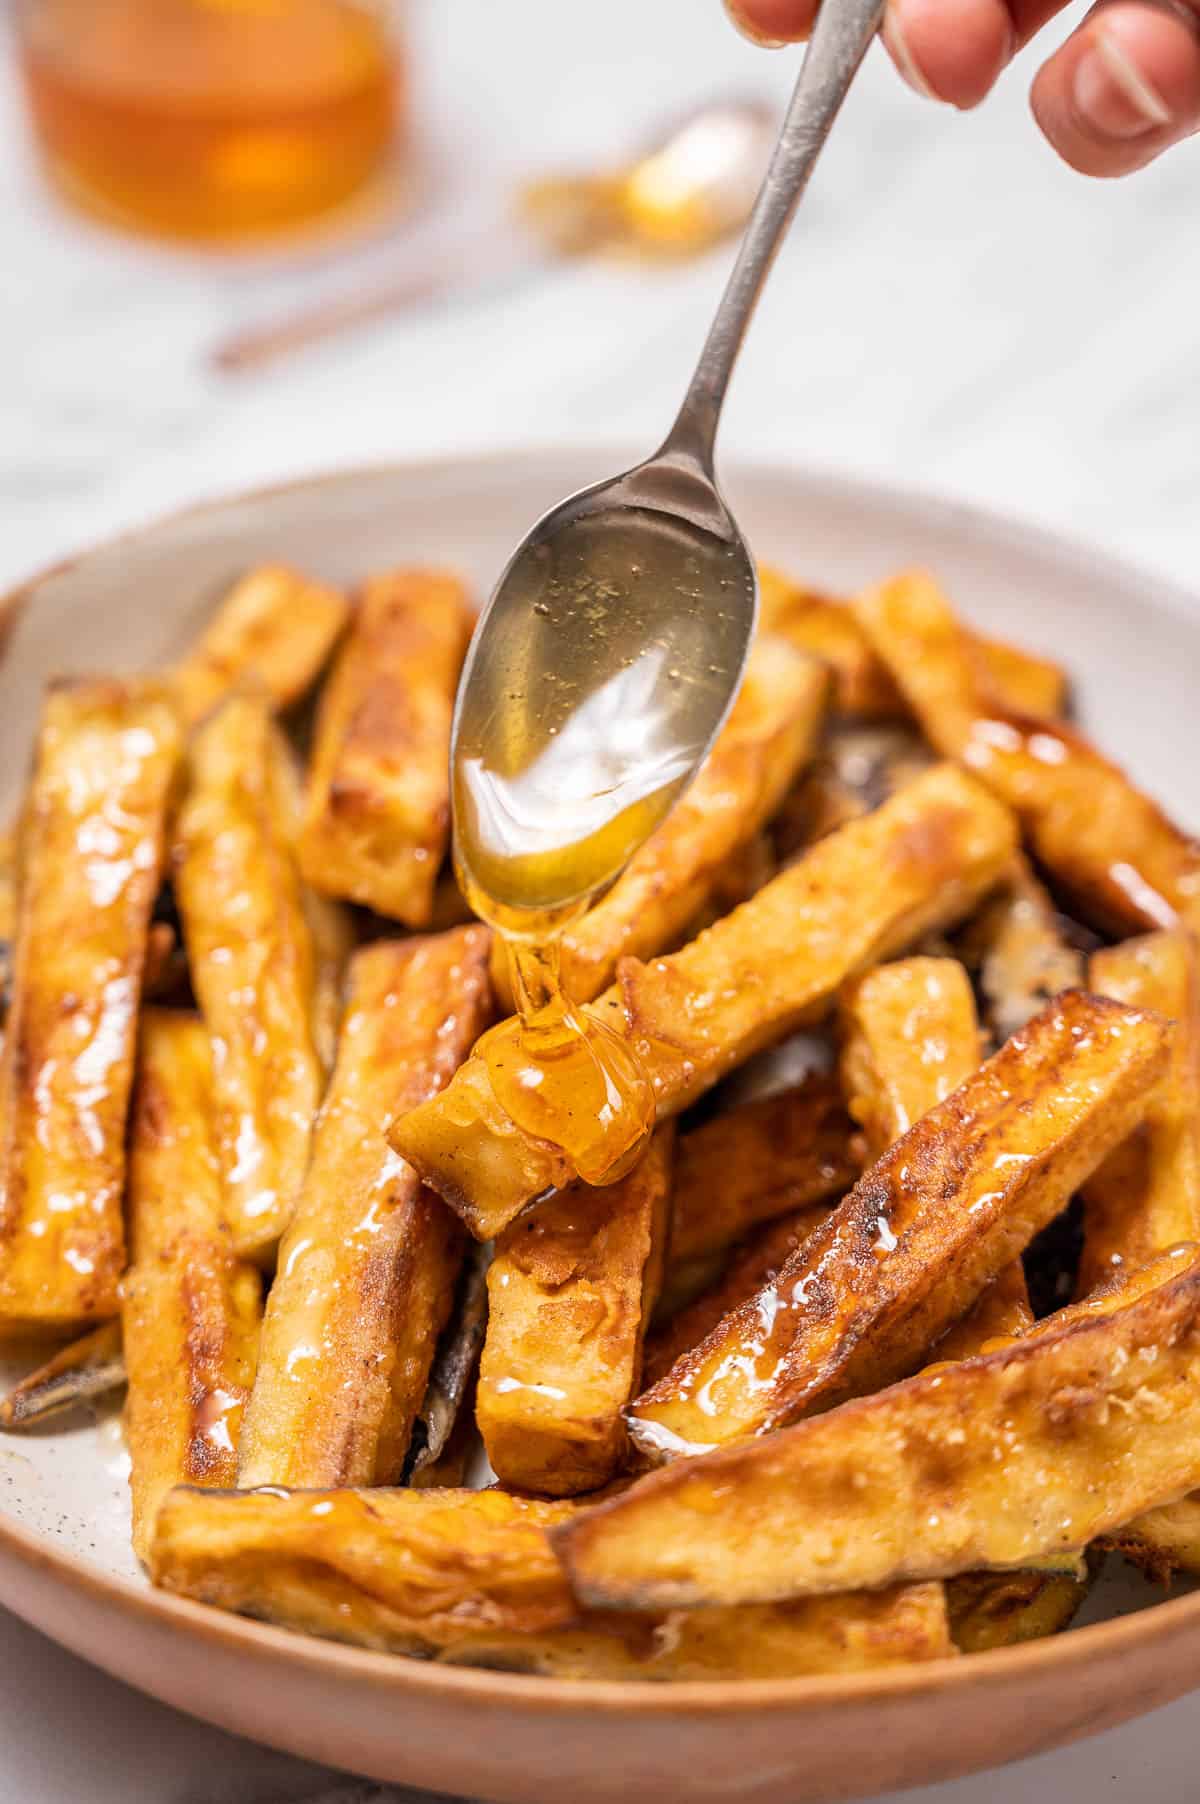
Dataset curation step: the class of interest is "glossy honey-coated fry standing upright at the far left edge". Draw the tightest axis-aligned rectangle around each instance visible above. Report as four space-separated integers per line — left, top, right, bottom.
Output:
0 680 180 1330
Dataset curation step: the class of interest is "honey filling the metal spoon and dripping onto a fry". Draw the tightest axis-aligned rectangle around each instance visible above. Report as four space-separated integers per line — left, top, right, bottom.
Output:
453 511 750 1183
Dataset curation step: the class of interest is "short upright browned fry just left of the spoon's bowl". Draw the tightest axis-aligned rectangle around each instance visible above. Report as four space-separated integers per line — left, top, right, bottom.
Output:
300 570 475 927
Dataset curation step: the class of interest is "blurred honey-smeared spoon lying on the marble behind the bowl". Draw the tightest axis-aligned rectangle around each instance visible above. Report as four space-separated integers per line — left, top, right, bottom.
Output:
211 99 776 372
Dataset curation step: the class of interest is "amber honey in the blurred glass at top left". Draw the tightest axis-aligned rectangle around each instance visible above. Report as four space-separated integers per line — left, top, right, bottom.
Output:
18 0 401 240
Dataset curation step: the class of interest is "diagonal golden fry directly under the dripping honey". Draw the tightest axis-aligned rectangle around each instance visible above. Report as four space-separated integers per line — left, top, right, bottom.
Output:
392 765 1014 1239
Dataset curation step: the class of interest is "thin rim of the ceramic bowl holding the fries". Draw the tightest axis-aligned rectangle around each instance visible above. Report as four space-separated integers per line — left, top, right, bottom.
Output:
0 440 1200 1716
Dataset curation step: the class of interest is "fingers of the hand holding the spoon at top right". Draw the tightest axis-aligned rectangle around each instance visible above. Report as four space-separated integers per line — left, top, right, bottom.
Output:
725 0 1200 175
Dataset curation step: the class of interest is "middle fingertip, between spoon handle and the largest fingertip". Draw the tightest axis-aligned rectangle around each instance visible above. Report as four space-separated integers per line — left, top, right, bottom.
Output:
884 0 1016 108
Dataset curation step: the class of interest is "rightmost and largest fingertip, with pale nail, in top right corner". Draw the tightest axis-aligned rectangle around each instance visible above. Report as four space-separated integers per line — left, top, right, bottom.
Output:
1030 0 1200 177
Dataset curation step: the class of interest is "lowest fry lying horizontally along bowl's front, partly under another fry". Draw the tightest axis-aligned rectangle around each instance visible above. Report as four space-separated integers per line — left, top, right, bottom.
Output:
152 1490 953 1680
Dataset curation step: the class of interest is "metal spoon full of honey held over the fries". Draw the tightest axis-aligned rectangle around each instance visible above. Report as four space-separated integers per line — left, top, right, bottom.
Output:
451 0 882 936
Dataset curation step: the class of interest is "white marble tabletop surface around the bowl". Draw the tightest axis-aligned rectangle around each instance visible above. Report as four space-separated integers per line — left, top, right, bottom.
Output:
0 0 1200 1804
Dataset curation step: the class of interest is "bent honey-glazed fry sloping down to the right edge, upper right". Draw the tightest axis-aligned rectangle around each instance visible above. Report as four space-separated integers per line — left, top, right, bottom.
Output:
855 572 1200 934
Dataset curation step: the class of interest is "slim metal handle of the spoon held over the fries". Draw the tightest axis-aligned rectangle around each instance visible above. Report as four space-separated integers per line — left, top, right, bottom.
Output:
662 0 884 476
